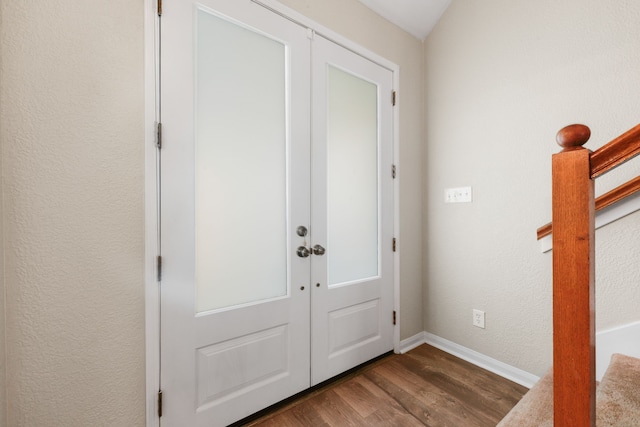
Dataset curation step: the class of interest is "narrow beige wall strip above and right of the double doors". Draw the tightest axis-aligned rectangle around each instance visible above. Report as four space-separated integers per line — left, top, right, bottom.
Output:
281 0 423 339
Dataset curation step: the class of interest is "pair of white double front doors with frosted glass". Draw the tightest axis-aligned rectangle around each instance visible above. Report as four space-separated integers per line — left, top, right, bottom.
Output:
160 0 393 426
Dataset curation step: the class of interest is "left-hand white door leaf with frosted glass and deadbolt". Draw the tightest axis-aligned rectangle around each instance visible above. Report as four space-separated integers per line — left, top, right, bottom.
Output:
161 0 310 426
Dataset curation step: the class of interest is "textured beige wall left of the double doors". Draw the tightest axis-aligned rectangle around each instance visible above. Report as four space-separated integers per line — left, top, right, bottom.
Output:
0 0 145 426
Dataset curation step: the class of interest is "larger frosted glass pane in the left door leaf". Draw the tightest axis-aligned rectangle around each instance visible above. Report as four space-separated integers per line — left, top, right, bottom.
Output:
195 10 288 312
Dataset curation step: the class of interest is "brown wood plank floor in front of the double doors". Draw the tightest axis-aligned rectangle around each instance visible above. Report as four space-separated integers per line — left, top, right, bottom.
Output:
242 344 527 427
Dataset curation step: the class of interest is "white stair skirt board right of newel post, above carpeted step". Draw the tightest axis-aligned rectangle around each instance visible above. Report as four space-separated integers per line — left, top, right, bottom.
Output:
596 322 640 381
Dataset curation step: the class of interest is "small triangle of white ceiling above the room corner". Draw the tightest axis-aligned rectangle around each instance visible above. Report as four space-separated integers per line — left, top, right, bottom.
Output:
360 0 451 40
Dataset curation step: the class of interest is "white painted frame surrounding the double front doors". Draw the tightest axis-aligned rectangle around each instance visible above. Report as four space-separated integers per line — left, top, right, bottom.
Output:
144 0 401 427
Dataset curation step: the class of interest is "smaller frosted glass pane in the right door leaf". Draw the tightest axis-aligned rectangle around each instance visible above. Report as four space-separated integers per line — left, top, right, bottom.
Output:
327 66 379 286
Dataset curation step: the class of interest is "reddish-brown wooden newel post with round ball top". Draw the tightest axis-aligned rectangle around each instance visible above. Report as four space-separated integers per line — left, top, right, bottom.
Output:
552 125 596 427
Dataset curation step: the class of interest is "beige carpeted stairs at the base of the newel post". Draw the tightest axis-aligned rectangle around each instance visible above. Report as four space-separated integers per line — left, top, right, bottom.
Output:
496 354 640 427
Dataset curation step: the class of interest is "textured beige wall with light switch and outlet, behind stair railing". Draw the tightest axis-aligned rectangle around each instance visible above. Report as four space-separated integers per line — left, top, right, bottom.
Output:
423 0 640 375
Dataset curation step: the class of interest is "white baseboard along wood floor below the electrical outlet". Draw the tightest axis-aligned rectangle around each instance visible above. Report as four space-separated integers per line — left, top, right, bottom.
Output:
400 332 540 388
